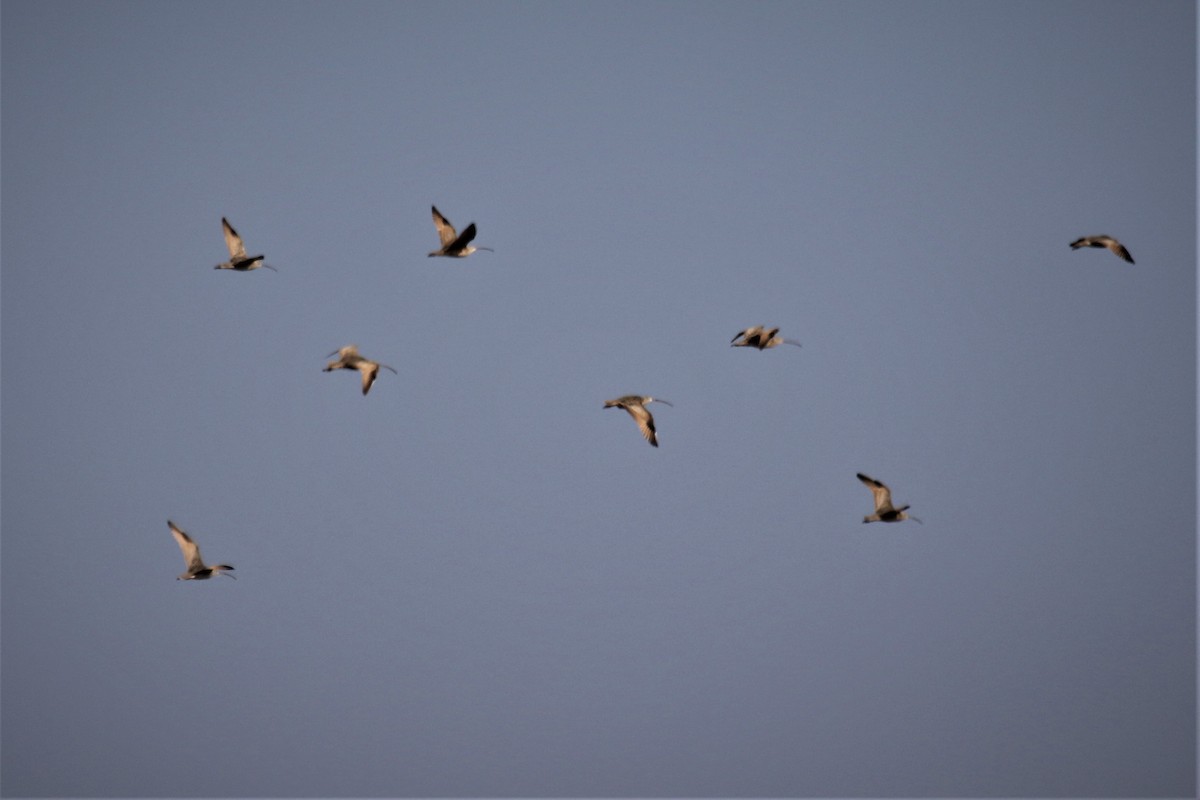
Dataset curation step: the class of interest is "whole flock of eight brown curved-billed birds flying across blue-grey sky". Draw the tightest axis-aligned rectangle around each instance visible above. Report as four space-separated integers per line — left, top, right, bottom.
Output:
167 206 1134 581
